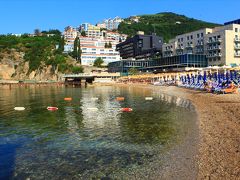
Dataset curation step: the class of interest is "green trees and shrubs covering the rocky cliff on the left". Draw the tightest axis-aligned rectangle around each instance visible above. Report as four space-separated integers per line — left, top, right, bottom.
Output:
0 31 83 80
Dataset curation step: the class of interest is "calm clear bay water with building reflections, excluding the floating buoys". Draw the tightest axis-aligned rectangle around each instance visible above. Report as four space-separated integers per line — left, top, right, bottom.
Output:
0 86 195 179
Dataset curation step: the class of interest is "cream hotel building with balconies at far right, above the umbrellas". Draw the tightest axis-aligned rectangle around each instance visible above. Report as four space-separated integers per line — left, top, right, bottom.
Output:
162 24 240 66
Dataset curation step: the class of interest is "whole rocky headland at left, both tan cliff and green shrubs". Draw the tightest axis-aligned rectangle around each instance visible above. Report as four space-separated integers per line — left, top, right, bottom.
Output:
0 32 82 81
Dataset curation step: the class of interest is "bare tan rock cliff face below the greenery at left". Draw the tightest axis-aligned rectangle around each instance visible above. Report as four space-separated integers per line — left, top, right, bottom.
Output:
0 49 69 81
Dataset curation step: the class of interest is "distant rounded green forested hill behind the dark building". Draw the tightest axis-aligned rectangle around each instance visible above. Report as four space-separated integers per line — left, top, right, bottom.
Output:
118 12 220 42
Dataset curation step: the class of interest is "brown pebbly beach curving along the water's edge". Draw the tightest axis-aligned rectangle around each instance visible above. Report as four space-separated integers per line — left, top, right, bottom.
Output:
113 84 240 179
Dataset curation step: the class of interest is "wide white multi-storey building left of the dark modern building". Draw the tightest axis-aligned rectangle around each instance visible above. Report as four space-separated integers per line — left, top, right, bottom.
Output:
80 36 121 66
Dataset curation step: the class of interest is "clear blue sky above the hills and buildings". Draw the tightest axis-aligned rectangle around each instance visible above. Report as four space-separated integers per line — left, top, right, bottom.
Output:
0 0 240 34
